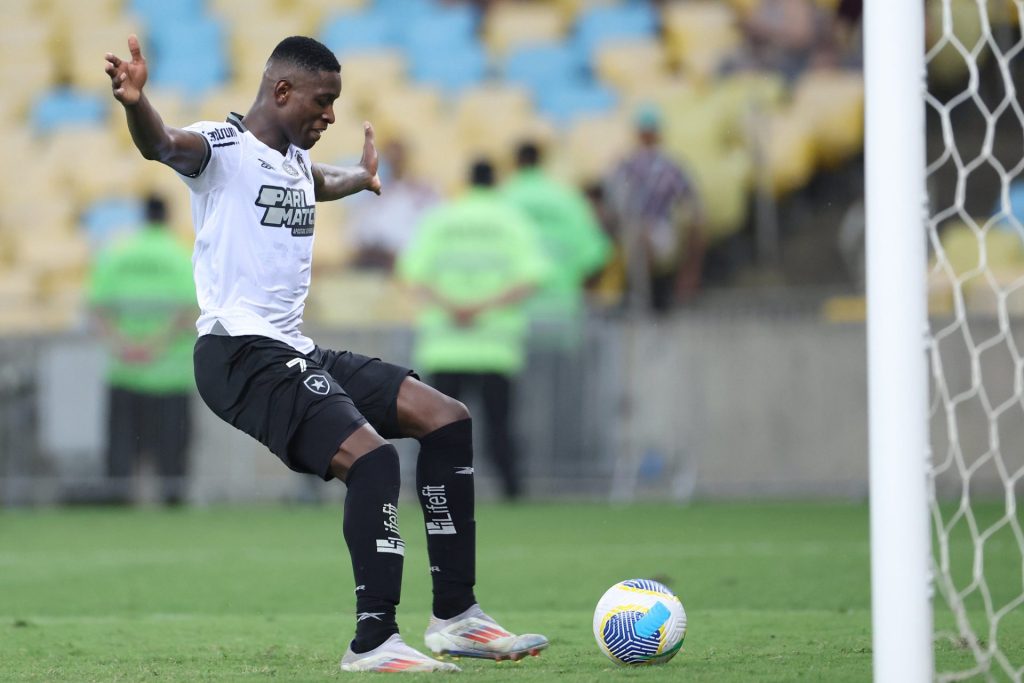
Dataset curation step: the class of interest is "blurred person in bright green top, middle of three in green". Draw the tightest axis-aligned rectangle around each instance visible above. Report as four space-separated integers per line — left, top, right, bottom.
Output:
396 161 551 500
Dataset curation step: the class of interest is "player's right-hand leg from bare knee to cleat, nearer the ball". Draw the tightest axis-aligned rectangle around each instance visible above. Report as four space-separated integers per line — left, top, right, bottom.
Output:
398 377 548 659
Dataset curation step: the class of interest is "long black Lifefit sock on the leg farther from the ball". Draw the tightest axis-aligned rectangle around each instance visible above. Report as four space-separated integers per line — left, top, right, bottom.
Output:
343 443 406 652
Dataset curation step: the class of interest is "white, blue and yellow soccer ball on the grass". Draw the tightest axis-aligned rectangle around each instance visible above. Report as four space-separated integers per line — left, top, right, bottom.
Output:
594 579 686 665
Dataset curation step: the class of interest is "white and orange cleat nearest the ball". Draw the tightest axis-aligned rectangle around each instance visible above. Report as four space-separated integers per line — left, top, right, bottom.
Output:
423 605 548 661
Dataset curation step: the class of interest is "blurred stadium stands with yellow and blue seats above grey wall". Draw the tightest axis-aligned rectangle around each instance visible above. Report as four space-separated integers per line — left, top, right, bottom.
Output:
0 0 1021 505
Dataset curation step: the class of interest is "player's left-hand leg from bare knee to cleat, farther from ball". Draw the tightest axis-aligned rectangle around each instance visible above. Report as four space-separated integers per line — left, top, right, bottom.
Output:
331 424 456 672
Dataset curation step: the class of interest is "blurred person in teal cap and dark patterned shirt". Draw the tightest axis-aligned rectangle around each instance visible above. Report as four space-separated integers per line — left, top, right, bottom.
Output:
605 105 705 313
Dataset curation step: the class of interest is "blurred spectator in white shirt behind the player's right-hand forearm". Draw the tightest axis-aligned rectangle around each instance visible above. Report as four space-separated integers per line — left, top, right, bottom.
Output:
351 140 440 272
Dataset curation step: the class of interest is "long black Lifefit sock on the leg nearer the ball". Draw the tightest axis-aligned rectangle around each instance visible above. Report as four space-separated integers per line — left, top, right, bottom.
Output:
416 419 476 618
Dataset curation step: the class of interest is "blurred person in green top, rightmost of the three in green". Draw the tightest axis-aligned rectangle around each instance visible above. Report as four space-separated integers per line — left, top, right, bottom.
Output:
502 142 611 348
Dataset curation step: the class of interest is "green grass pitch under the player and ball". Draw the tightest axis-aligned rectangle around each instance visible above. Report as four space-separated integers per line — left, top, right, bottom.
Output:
0 501 1024 683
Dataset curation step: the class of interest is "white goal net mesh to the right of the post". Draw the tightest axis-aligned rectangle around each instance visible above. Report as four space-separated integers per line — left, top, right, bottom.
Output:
926 0 1024 681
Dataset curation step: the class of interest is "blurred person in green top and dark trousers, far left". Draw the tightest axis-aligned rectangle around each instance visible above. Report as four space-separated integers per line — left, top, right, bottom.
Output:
88 196 197 505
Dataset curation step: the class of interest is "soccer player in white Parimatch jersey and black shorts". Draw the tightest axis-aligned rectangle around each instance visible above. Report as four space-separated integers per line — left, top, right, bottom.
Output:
105 36 548 672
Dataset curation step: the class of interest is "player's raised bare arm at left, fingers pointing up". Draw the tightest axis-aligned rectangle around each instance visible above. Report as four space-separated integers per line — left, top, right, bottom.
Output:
105 36 208 175
